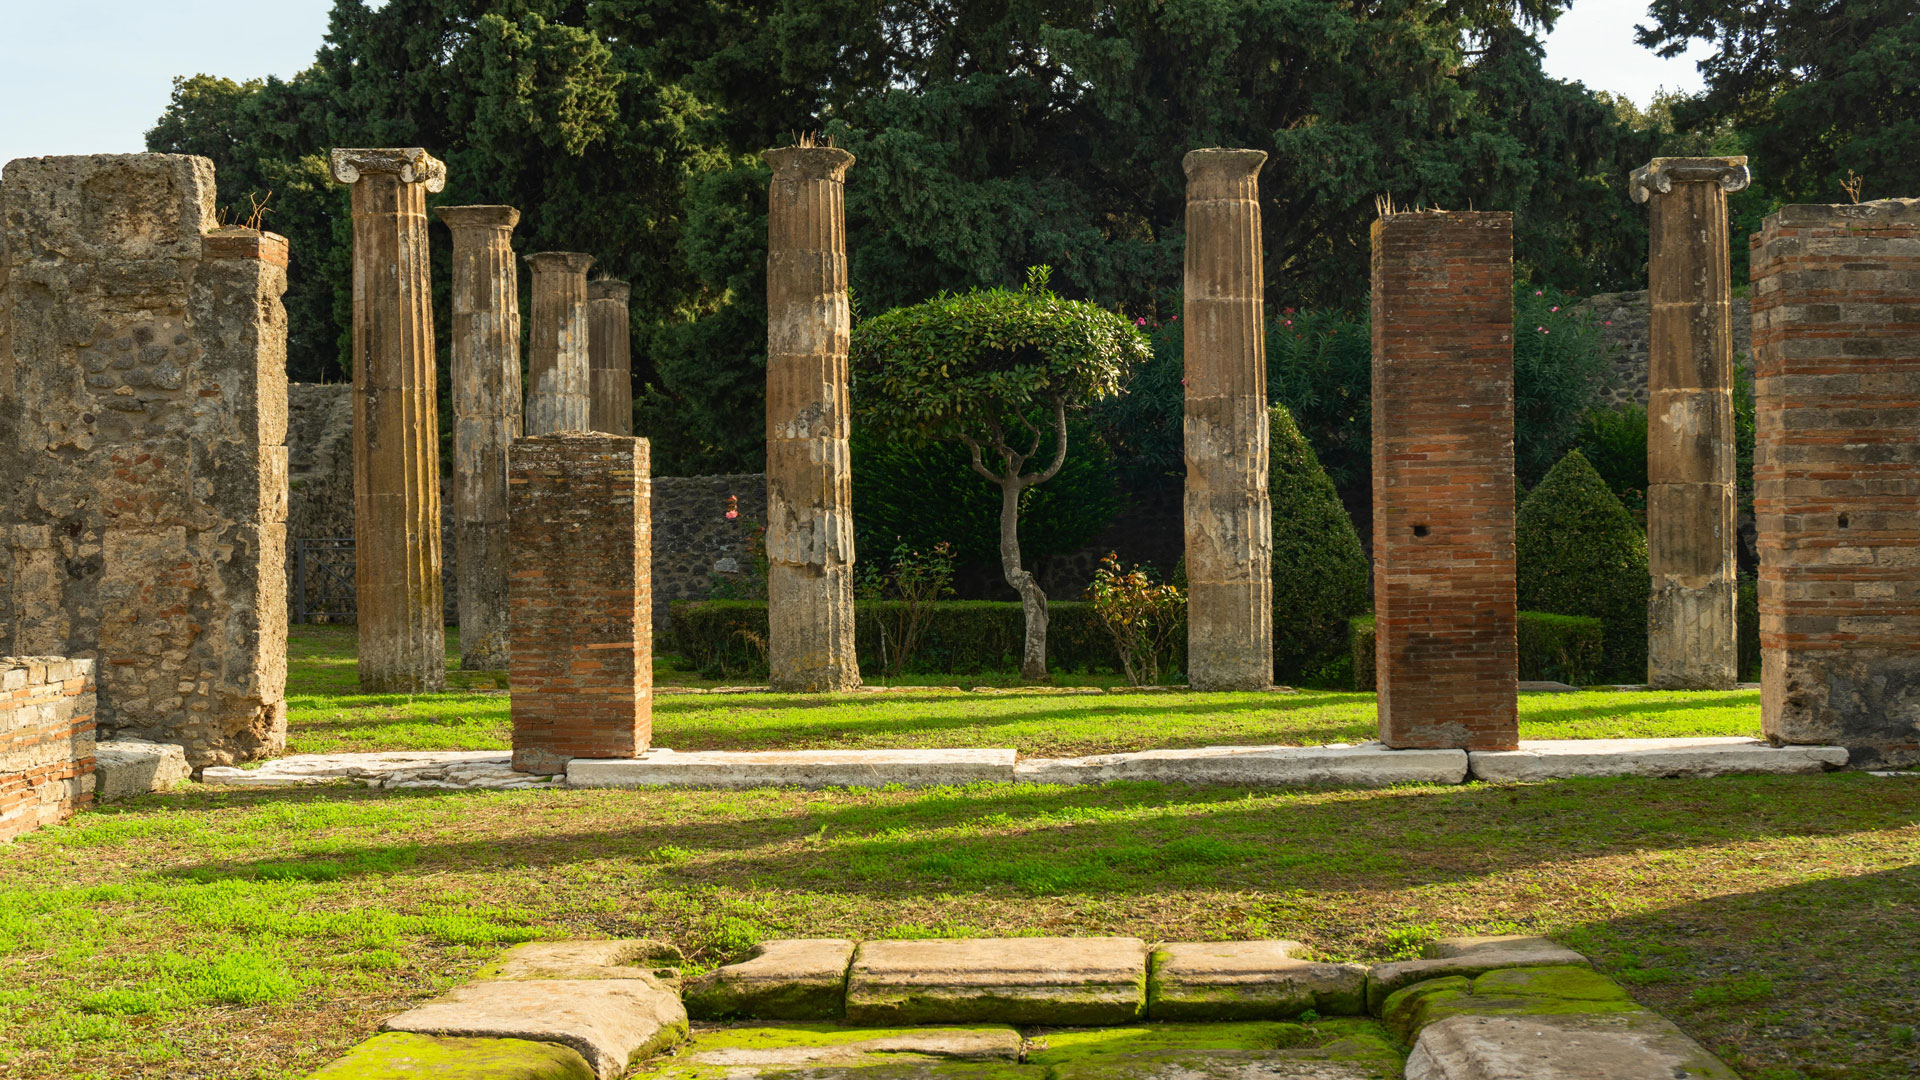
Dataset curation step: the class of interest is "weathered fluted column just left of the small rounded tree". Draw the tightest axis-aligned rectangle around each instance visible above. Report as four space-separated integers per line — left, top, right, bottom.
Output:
766 146 860 692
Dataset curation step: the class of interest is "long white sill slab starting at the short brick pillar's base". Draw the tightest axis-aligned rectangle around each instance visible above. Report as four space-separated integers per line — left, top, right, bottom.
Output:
566 749 1018 788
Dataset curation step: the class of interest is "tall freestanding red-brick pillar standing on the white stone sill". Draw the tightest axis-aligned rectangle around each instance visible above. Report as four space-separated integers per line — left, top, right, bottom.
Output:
1373 213 1519 749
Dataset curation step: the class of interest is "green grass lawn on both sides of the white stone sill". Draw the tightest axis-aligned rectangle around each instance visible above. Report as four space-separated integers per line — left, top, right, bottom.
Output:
0 626 1920 1080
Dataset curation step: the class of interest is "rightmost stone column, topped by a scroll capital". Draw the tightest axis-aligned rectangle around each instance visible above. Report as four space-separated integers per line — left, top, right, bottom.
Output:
1628 158 1747 690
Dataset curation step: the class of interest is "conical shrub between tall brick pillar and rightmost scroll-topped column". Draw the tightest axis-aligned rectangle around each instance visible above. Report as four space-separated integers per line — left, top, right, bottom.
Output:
1515 450 1651 682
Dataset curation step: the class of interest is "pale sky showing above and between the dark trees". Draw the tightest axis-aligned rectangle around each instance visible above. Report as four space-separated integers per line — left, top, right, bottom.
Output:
0 0 1699 163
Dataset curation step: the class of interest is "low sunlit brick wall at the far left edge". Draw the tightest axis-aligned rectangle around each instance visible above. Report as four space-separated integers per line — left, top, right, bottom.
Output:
0 655 94 842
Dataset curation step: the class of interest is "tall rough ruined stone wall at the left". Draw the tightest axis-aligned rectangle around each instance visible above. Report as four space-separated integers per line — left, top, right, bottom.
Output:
0 154 286 767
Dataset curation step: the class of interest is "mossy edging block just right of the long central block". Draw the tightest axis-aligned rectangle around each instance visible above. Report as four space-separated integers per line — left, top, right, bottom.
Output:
1146 940 1367 1020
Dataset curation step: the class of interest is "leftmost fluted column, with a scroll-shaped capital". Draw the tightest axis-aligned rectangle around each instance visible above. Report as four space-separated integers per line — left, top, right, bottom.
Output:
332 146 447 694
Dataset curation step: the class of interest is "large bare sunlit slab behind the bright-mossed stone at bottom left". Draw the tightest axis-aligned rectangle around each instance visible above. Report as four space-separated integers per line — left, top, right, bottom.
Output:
384 978 687 1080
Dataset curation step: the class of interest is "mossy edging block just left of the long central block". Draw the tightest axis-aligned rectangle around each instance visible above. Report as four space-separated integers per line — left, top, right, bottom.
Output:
684 938 854 1020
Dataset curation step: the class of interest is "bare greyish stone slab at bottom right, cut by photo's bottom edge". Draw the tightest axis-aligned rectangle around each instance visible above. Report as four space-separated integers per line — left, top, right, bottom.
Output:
1407 1011 1736 1080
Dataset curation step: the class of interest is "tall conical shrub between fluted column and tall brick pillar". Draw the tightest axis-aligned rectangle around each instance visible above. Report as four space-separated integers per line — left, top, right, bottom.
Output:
1267 405 1369 682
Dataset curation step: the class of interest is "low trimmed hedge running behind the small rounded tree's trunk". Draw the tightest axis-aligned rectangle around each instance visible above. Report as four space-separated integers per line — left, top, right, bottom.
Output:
668 600 1187 678
